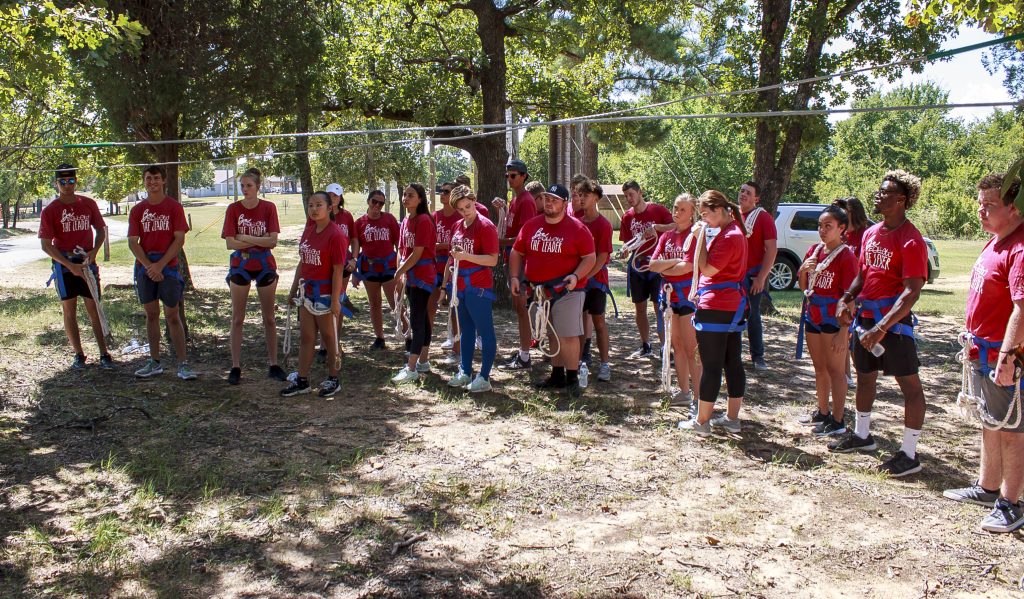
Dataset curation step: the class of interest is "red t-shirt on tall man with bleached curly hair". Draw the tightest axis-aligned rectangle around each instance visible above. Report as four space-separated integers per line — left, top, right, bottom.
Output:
860 220 928 301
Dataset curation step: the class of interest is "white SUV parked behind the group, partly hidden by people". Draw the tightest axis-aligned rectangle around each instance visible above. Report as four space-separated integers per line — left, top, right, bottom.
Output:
768 203 939 291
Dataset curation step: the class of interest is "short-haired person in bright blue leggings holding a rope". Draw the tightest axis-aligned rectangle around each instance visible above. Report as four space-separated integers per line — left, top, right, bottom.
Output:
442 185 498 393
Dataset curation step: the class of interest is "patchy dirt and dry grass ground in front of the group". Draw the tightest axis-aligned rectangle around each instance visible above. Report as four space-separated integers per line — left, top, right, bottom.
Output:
0 267 1024 598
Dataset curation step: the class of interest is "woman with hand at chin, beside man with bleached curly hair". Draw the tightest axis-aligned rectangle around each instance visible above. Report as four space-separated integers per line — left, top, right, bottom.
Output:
797 205 857 436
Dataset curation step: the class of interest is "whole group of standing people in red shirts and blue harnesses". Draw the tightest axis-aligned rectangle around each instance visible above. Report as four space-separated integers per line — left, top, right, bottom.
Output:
39 160 1024 531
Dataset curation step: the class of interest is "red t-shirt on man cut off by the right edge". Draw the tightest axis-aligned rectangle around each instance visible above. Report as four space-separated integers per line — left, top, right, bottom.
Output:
967 225 1024 350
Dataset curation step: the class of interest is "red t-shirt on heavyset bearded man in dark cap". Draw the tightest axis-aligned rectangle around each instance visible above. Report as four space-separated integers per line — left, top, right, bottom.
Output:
512 216 594 289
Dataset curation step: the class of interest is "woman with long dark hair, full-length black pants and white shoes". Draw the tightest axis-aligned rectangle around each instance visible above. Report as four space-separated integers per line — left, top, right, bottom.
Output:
391 183 437 383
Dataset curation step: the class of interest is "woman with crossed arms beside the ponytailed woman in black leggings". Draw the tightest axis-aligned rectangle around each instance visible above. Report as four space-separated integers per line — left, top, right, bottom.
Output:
650 194 700 409
